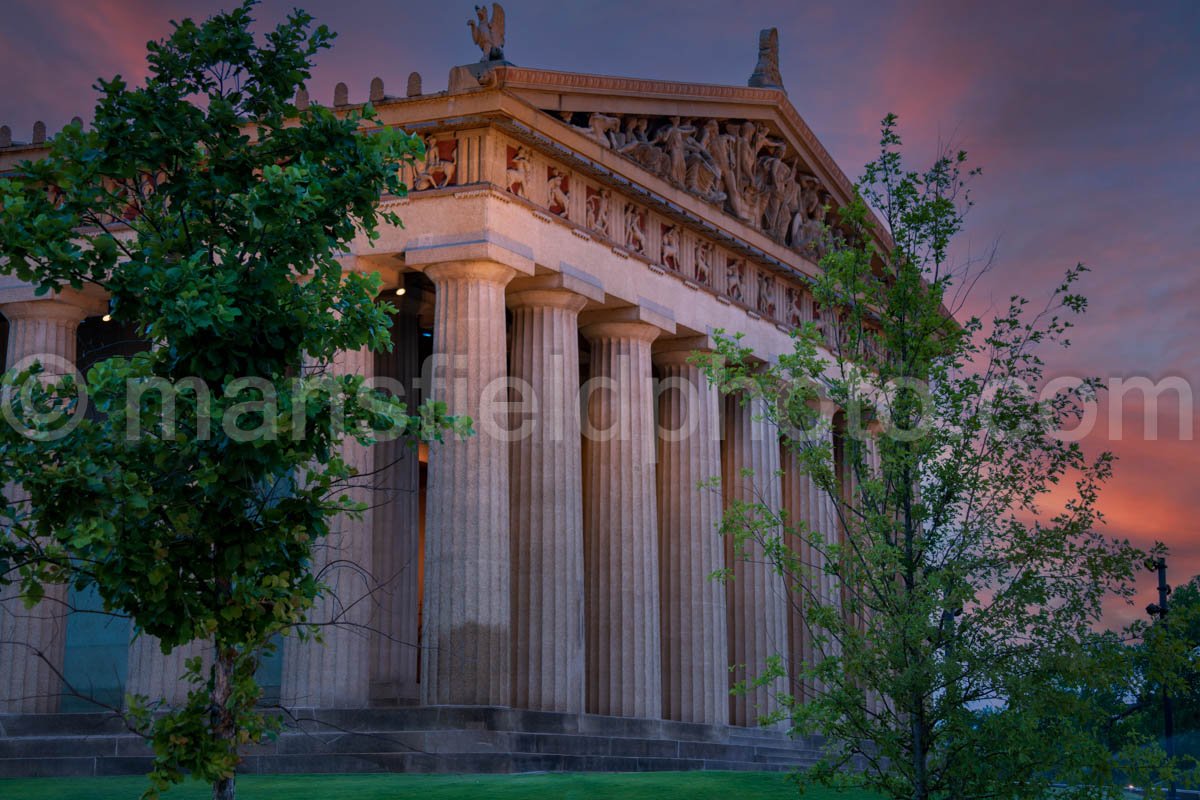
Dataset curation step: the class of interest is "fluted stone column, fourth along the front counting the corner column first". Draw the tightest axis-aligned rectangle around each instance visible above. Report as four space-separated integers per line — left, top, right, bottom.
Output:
655 343 730 724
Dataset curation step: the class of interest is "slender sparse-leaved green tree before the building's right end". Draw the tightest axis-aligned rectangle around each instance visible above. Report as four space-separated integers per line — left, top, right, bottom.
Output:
694 115 1146 800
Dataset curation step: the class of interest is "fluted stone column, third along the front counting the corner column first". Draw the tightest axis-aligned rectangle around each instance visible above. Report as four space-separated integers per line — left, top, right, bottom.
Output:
583 311 662 718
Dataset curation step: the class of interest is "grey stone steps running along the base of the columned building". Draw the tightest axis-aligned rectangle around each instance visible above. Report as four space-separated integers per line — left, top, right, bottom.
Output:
0 706 821 777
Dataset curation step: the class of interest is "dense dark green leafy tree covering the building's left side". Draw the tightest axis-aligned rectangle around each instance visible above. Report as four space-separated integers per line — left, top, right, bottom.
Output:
0 0 460 798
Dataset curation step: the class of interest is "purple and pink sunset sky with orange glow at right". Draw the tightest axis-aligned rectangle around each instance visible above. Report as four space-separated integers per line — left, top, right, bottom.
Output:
0 0 1200 622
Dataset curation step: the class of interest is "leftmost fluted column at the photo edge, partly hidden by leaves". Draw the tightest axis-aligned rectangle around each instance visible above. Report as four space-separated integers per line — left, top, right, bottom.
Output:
0 297 88 714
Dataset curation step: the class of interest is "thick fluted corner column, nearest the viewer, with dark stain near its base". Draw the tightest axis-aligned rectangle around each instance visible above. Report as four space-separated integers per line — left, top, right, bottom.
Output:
421 261 514 705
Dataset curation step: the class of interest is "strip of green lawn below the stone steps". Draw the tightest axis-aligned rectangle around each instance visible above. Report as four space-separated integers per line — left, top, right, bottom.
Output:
0 772 869 800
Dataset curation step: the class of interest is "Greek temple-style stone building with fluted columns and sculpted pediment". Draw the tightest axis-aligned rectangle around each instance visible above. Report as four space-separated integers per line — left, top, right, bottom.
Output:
0 12 883 775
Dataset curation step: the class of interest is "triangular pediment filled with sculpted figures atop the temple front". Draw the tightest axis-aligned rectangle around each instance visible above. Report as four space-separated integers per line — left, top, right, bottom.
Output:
491 66 873 260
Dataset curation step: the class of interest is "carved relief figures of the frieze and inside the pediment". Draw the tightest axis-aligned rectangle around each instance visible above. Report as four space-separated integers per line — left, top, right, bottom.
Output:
398 128 832 336
